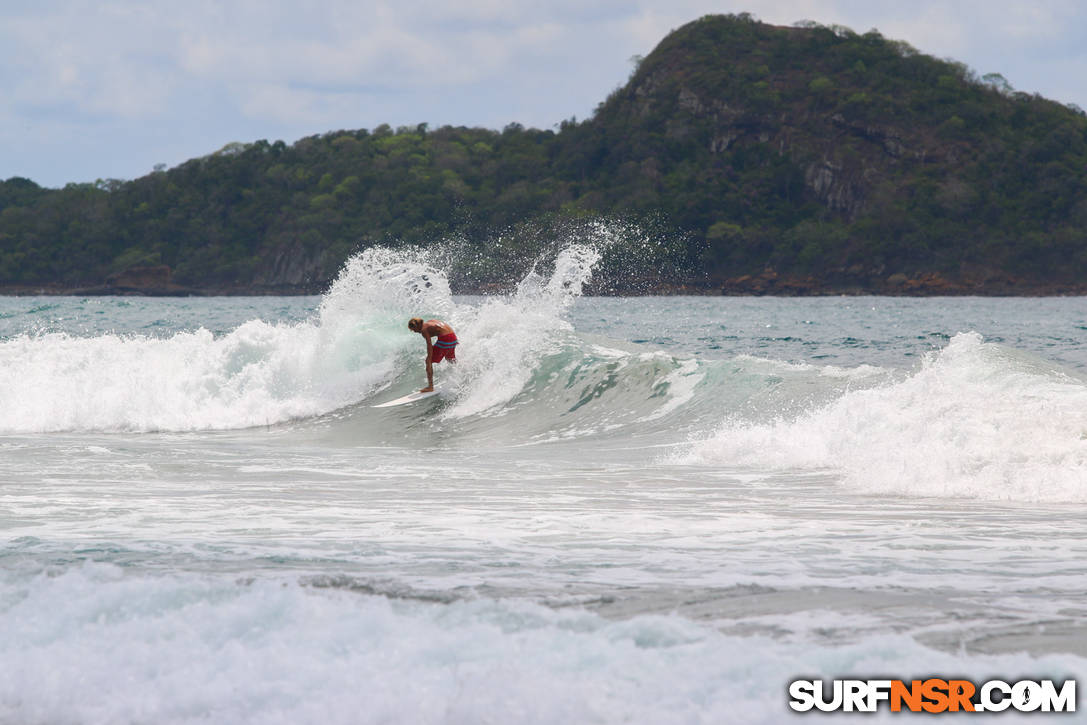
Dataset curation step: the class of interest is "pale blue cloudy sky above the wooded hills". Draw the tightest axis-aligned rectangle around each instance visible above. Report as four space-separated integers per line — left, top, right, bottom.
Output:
0 0 1087 187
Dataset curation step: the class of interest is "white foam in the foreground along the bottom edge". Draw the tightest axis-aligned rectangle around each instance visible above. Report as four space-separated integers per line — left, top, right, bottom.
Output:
0 565 1087 725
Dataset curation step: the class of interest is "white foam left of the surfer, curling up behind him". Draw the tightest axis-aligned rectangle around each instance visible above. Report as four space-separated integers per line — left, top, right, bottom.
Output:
0 249 452 433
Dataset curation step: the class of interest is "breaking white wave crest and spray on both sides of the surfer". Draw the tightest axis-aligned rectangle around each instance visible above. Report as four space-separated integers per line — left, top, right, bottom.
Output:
0 245 613 433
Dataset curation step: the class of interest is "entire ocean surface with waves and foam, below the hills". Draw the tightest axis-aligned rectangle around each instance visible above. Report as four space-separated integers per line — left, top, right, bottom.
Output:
0 246 1087 725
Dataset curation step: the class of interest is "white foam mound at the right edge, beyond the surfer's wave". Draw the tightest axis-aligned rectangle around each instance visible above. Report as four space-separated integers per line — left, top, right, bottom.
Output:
689 333 1087 501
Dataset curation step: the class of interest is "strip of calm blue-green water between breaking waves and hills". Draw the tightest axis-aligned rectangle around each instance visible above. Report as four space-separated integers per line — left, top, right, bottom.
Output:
8 297 1087 368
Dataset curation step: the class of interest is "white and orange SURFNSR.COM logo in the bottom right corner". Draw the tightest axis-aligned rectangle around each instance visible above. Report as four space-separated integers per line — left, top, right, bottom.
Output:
789 677 1076 713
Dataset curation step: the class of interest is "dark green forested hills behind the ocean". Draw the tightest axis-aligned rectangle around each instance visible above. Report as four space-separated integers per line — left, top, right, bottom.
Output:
0 15 1087 288
